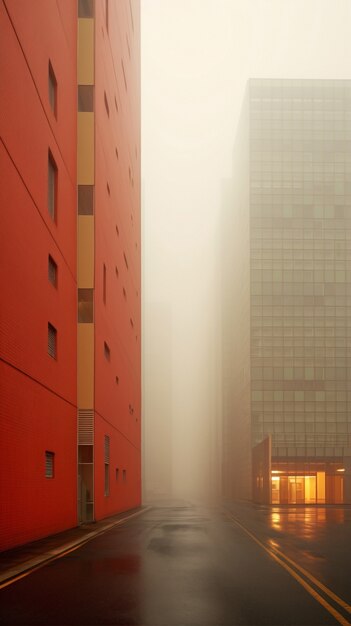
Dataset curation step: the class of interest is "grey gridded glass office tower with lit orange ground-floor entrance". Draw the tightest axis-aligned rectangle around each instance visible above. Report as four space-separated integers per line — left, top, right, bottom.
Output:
224 80 351 504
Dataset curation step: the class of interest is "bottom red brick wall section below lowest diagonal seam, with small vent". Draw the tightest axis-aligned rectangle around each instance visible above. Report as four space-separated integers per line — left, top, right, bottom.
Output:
0 361 77 550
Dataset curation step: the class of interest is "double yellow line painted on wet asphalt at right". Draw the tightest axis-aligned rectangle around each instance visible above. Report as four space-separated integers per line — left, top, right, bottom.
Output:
228 515 351 626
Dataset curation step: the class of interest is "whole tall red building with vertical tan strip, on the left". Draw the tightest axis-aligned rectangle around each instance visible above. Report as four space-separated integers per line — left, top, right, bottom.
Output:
0 0 140 549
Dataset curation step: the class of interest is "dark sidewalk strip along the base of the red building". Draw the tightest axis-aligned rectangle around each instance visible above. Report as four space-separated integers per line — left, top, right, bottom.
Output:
0 506 150 589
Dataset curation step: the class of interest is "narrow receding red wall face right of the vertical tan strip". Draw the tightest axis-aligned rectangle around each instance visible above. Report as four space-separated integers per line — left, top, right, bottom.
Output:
95 1 141 519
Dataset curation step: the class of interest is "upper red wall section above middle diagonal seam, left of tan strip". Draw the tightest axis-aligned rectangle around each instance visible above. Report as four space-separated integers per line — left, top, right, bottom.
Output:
0 0 77 269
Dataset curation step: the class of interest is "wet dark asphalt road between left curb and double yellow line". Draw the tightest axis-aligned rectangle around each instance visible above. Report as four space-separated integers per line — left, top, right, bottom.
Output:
0 504 350 626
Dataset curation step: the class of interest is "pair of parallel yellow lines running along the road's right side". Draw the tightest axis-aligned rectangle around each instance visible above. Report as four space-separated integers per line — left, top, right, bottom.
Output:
227 513 351 626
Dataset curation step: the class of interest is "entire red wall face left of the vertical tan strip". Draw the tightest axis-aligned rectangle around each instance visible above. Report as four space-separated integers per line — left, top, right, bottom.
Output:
0 0 77 549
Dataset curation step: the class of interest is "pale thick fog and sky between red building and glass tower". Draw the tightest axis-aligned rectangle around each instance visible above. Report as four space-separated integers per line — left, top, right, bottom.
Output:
141 0 351 501
